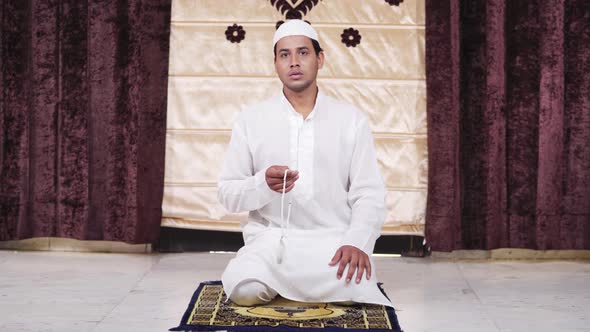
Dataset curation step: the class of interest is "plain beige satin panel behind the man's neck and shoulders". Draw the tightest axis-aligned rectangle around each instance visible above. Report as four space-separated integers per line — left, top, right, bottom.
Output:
167 77 426 134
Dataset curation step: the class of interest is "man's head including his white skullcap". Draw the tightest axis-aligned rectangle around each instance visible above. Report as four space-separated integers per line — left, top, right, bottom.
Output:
273 20 324 92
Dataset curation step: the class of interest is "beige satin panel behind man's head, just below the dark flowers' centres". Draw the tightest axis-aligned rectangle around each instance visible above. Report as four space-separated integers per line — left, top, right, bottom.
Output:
169 23 425 80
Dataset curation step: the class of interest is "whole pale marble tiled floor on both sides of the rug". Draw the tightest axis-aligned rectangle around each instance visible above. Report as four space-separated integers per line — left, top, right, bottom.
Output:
0 251 590 332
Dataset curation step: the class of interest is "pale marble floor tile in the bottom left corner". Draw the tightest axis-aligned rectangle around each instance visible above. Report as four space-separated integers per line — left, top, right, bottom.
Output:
0 252 159 331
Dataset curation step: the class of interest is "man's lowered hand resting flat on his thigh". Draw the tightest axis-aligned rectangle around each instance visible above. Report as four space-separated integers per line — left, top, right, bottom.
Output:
330 246 371 284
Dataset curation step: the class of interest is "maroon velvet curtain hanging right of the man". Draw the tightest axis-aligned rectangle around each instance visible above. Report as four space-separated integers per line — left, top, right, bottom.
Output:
426 0 590 251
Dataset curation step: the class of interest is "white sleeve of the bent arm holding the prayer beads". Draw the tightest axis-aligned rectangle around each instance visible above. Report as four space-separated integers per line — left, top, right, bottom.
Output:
217 118 278 213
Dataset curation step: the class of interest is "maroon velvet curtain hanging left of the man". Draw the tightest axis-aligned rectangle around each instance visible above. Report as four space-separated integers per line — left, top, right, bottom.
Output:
0 0 171 243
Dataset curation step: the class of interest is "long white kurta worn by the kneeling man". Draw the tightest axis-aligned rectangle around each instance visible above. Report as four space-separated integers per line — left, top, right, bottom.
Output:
219 92 391 306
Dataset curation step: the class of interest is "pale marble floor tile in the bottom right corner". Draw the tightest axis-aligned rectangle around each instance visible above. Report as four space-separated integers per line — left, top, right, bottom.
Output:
459 261 590 332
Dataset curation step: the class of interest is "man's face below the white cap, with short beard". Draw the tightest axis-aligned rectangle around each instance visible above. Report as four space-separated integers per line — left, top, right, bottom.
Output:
275 36 324 92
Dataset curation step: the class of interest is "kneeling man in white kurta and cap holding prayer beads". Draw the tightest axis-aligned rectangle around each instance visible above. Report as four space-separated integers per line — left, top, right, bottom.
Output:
218 20 391 306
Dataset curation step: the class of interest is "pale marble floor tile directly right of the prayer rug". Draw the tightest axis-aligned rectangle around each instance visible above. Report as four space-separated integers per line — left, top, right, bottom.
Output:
375 258 499 332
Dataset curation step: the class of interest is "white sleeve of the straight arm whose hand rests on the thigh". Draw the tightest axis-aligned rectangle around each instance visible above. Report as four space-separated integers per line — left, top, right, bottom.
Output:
341 116 386 255
